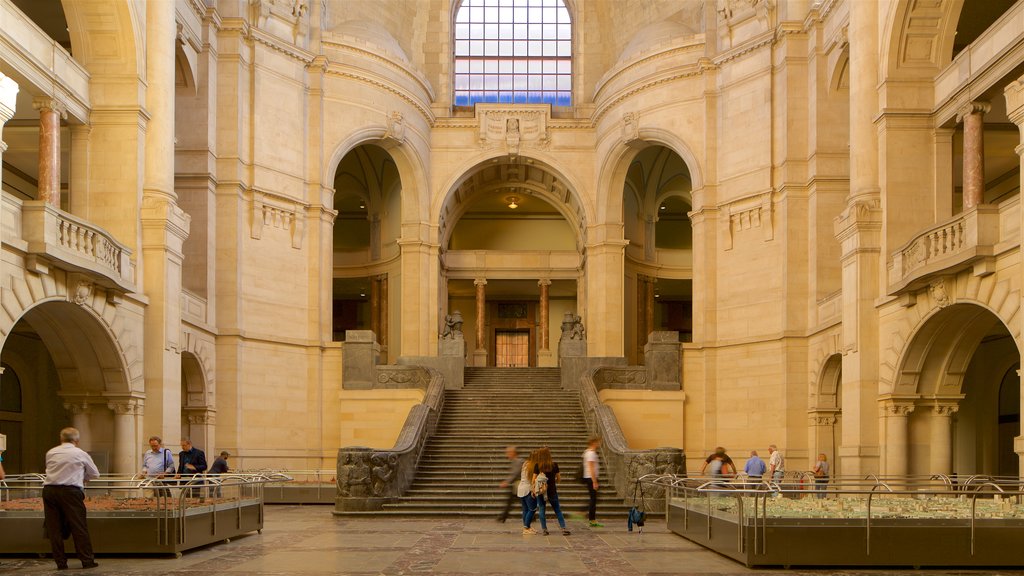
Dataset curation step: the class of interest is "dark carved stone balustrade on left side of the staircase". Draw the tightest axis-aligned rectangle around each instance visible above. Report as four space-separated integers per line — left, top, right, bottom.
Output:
335 366 444 513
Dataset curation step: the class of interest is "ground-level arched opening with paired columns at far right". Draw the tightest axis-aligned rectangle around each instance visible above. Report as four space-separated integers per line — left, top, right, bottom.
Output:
881 303 1020 476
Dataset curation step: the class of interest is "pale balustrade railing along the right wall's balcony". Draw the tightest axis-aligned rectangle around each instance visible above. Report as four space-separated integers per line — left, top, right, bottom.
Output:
889 204 999 293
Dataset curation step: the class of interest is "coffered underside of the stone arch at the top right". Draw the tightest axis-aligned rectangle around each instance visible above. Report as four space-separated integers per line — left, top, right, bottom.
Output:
879 0 965 79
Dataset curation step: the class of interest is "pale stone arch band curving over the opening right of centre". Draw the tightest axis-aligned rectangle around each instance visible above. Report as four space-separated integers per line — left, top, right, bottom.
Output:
597 128 705 222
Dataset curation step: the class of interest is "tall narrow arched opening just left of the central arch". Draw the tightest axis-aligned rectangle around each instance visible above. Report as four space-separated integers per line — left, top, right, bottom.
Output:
333 145 401 362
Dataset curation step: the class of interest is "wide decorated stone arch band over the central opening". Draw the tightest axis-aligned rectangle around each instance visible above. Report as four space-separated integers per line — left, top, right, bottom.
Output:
430 151 593 248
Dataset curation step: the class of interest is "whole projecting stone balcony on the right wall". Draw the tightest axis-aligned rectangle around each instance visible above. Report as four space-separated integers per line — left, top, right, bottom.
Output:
889 199 1020 294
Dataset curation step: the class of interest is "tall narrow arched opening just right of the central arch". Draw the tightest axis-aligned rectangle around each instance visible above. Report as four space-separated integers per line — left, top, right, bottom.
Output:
623 146 693 364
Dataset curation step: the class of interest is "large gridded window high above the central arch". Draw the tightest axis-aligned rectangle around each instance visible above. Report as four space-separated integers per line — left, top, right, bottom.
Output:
455 0 572 106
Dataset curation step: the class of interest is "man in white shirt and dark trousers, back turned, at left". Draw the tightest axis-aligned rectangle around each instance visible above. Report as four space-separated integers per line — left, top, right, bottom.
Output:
43 428 99 570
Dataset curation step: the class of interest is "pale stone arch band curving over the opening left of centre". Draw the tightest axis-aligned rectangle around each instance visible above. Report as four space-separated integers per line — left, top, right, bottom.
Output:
321 124 430 222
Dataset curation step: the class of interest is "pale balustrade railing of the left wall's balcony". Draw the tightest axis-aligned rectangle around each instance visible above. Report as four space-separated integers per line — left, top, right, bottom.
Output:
22 201 135 292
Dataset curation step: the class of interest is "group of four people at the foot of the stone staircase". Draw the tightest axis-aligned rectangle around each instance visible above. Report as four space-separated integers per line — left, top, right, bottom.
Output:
498 438 603 536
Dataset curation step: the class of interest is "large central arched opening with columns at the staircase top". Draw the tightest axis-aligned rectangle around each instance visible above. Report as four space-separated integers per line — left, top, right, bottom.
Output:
439 157 586 367
